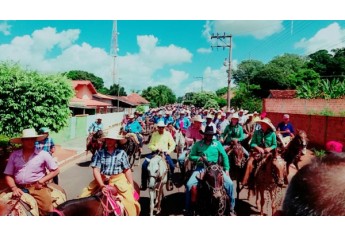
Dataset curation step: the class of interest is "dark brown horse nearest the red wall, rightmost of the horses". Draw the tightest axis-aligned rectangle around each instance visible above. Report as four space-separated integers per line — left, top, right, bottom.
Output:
282 130 308 175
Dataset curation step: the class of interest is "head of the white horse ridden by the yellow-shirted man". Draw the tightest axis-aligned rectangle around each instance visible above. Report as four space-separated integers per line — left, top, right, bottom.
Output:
147 155 167 189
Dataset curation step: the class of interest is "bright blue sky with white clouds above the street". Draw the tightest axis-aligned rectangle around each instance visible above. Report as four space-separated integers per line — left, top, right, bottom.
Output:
0 20 345 96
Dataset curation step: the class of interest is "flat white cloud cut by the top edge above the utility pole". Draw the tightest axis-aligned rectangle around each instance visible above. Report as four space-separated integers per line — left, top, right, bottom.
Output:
203 20 284 41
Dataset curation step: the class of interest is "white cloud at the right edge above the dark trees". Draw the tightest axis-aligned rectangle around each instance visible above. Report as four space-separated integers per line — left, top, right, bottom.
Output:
295 23 345 55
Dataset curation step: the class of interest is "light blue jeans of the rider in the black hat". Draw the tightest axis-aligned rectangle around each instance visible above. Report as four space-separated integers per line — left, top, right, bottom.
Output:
185 167 235 211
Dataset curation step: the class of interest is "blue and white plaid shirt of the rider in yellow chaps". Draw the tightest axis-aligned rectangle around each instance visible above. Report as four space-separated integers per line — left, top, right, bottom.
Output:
91 149 130 175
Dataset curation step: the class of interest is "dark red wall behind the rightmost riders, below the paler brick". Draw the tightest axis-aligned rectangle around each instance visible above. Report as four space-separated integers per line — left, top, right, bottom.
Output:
267 112 345 149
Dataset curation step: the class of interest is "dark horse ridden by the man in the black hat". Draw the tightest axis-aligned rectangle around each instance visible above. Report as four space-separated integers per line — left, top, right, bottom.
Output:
191 162 230 216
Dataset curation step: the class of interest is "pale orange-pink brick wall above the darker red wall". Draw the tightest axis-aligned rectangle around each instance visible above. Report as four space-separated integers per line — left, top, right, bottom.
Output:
263 98 345 116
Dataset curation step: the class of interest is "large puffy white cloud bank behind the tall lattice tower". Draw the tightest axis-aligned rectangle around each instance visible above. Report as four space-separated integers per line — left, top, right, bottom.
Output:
0 27 193 96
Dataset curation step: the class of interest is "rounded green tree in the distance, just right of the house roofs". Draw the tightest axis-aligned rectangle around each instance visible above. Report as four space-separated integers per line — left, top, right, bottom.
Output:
141 85 176 107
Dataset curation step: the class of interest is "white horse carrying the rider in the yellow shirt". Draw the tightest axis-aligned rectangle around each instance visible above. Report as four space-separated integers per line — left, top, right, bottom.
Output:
146 154 168 216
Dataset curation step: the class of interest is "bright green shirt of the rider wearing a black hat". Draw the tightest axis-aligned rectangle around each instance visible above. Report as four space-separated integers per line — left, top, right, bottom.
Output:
189 140 230 171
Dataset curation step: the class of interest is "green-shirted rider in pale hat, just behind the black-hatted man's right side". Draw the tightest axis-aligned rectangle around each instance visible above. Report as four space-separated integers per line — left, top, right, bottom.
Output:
220 114 249 158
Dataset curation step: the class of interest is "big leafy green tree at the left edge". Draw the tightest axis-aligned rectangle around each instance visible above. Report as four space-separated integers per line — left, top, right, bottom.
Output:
0 63 74 137
